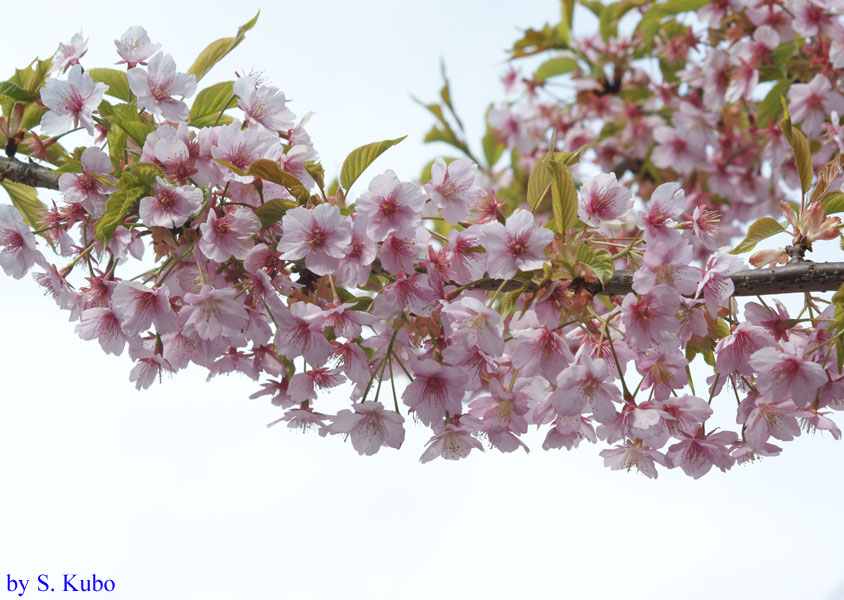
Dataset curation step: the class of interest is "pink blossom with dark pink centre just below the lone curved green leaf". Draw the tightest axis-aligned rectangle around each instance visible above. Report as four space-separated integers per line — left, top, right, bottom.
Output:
355 170 425 242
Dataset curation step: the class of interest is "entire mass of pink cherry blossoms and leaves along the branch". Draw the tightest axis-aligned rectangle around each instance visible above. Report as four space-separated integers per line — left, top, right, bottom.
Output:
0 0 844 478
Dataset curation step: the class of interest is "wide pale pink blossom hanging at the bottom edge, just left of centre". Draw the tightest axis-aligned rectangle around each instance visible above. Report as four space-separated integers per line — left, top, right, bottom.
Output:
327 402 404 456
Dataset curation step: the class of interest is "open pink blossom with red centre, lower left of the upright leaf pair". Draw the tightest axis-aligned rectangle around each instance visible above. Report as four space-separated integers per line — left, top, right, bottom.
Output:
483 209 554 279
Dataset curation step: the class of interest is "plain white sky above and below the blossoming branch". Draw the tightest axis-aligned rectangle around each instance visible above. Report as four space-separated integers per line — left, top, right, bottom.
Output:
0 0 844 600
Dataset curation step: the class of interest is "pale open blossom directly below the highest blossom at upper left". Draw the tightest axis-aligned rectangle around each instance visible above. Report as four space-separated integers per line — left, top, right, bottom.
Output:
126 52 196 121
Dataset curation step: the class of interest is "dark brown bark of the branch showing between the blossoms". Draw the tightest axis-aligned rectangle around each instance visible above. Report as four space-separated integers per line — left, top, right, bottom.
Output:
0 157 844 296
